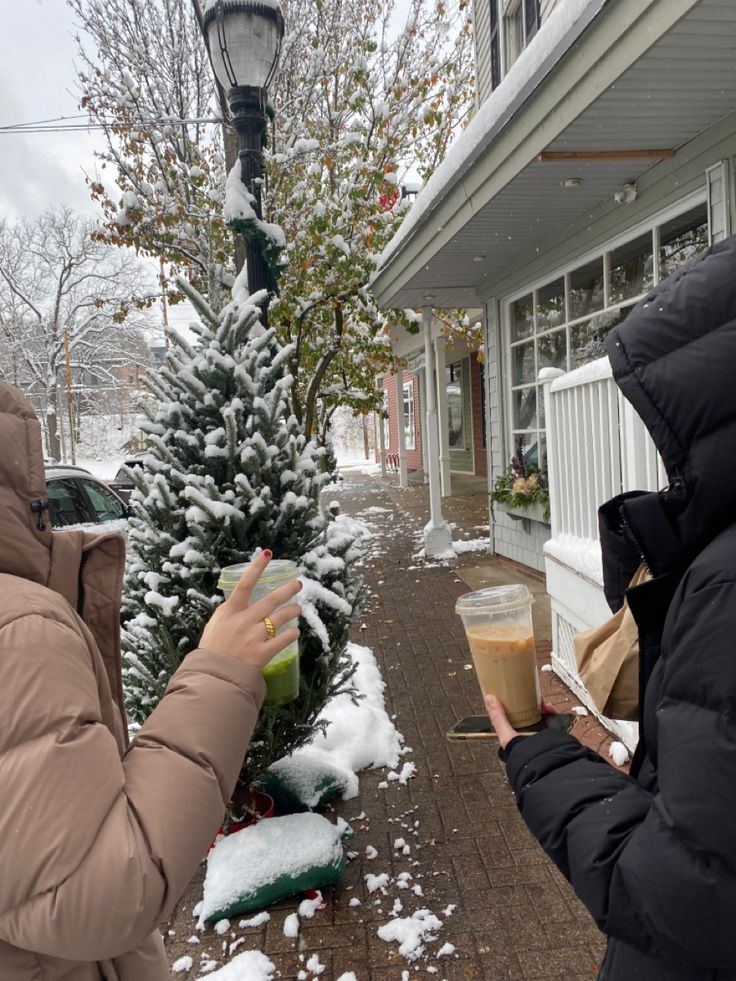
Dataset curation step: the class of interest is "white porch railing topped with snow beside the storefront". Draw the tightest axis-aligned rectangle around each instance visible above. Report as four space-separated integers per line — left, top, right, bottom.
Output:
540 358 667 749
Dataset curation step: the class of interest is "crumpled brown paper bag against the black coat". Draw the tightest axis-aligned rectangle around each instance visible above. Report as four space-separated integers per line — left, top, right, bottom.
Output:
573 564 651 722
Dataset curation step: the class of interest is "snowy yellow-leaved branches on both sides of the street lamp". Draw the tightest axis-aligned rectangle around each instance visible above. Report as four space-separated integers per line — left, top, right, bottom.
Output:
69 0 474 433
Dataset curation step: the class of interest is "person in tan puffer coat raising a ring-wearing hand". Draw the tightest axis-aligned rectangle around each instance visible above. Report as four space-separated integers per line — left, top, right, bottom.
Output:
0 382 299 981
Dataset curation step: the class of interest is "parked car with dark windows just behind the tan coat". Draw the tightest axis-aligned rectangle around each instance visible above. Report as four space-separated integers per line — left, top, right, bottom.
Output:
46 464 130 528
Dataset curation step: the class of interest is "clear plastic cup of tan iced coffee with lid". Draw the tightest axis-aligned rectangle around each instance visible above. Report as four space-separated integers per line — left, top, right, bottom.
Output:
455 585 541 729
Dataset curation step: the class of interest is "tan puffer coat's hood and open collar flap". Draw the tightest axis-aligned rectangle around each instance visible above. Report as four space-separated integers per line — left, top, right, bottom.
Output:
0 381 125 710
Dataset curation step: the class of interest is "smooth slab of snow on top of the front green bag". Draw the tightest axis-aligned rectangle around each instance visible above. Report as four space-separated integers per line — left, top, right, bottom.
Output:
197 813 348 927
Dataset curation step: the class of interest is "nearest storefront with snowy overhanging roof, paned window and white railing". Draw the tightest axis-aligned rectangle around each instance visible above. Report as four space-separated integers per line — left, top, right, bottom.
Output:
373 0 736 744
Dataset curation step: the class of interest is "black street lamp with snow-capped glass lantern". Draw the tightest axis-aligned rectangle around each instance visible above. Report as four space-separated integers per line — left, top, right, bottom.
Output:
202 0 284 294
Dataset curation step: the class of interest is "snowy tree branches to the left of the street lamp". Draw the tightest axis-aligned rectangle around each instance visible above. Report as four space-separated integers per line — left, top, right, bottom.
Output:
68 0 235 306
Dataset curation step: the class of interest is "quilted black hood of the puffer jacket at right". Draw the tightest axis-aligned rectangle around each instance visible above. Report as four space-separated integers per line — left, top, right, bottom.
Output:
606 236 736 573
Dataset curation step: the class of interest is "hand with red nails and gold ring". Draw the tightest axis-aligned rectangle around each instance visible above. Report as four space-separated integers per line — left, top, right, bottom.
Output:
199 550 302 668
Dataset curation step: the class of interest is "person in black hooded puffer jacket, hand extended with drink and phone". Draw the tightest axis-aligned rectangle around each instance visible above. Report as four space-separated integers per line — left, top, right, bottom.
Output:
487 236 736 981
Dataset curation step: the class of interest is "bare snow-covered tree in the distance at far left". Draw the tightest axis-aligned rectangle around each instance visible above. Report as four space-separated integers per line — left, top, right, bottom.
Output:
0 208 155 459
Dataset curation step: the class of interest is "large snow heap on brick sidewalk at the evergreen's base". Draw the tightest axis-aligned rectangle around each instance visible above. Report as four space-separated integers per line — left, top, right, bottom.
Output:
272 644 406 807
